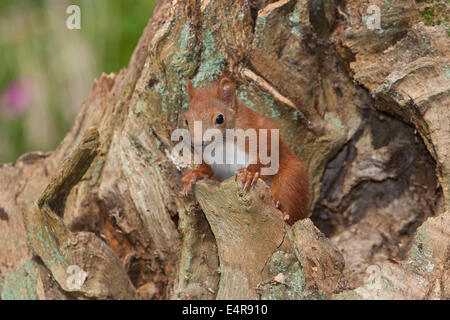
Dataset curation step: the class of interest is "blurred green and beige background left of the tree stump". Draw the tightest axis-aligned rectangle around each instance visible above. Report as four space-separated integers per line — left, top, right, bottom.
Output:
0 0 157 163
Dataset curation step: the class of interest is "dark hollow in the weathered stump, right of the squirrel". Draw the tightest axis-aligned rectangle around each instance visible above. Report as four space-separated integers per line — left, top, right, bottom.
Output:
311 109 441 288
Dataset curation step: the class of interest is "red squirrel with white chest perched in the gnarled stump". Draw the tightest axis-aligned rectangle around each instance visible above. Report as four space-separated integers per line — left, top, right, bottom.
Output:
181 76 309 225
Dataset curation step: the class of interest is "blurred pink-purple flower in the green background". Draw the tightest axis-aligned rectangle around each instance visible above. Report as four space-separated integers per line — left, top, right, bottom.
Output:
1 80 32 118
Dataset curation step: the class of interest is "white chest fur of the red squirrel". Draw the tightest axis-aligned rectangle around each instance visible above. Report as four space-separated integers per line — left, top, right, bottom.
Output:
203 143 250 180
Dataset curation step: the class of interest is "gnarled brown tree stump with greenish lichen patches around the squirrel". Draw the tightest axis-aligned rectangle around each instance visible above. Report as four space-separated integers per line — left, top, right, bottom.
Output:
0 0 450 299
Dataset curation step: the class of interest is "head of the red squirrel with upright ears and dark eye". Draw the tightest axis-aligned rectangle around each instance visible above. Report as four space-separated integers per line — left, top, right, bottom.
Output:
186 76 238 142
